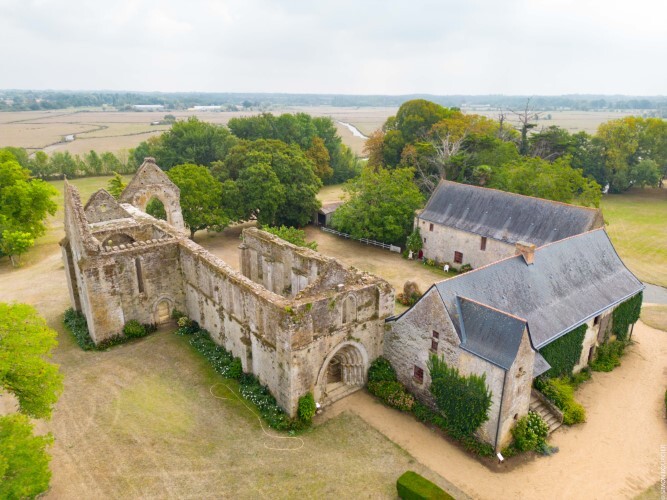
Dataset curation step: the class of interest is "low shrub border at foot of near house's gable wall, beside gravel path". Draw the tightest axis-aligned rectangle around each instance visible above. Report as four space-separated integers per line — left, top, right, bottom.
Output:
368 357 494 457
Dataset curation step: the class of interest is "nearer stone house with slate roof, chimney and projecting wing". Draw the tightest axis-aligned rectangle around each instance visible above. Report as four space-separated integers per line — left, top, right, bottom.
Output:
384 229 644 450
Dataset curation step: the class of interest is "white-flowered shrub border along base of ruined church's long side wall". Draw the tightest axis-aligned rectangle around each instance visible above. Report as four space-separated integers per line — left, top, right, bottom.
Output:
172 311 308 431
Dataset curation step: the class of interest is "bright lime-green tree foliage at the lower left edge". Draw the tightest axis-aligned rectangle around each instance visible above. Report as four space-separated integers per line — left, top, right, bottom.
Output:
0 303 63 498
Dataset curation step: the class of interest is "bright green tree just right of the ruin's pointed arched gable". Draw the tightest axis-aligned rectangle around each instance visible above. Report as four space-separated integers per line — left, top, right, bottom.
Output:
167 164 229 238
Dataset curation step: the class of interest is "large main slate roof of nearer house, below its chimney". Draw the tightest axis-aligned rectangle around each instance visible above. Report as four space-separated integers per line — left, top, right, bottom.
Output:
435 229 644 349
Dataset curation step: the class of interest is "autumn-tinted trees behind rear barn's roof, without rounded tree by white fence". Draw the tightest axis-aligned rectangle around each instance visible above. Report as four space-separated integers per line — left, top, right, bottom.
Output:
366 100 667 200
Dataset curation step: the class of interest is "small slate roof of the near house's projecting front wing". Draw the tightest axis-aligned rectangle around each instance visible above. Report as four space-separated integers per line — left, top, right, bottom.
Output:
457 297 526 370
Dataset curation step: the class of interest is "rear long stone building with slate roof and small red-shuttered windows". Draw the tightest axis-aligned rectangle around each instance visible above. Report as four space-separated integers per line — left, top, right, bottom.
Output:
415 180 604 268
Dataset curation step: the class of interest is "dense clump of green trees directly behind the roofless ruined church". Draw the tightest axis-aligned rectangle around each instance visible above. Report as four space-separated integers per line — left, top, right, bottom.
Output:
132 114 359 240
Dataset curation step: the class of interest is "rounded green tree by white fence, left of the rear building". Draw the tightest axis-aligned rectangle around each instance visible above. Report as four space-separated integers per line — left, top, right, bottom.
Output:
333 167 423 244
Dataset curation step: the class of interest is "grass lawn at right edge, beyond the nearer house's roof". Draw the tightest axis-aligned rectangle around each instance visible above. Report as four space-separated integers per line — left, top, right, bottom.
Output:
601 189 667 286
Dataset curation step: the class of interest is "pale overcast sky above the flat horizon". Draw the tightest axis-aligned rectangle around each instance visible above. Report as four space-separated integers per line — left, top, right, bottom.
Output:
0 0 667 95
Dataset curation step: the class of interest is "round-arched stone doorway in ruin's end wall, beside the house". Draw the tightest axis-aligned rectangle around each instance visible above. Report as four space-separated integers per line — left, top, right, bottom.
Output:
315 341 368 406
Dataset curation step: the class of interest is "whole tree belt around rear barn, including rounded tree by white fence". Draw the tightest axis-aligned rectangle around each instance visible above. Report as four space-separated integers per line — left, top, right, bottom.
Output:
333 99 667 244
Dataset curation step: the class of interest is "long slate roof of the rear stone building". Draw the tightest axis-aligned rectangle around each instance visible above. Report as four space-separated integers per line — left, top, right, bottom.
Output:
419 181 602 246
